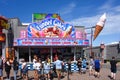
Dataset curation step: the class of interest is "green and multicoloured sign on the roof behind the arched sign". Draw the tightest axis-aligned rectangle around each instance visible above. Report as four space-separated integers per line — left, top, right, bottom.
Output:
32 13 61 22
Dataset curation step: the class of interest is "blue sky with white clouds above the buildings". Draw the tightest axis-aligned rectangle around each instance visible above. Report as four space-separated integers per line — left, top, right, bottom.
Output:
0 0 120 46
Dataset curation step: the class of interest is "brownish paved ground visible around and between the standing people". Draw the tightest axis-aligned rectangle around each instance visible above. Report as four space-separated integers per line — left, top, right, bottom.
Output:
3 64 120 80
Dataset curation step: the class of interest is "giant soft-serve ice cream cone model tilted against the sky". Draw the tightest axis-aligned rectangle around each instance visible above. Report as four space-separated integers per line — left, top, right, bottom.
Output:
93 13 106 40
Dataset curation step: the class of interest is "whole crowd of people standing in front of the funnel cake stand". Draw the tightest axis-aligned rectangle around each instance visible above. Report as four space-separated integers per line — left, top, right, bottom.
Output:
0 55 117 80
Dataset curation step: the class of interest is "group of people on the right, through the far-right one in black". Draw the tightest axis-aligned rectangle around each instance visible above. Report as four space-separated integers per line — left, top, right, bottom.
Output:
77 57 117 80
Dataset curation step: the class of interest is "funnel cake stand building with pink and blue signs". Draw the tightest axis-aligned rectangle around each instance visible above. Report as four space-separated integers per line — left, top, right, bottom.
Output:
2 13 89 62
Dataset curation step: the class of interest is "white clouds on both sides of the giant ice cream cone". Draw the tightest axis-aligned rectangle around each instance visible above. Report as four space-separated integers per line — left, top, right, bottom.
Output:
70 5 120 35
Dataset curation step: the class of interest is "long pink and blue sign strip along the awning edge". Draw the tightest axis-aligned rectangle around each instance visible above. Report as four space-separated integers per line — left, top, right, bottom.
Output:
14 38 89 46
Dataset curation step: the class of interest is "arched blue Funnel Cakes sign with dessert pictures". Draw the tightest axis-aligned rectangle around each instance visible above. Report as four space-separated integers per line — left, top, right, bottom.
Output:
27 18 75 38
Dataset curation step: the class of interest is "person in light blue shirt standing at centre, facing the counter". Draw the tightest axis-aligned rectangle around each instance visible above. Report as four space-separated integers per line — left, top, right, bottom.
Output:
53 57 63 80
